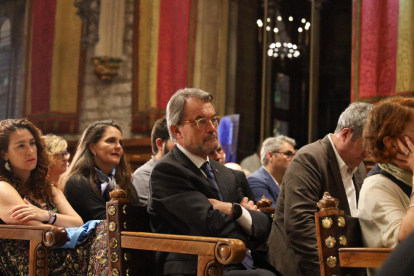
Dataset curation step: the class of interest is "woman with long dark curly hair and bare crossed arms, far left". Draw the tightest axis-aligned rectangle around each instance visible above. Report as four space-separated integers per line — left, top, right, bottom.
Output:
0 119 107 275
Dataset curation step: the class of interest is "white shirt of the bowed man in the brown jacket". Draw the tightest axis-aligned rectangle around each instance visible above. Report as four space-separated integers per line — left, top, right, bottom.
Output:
328 134 358 217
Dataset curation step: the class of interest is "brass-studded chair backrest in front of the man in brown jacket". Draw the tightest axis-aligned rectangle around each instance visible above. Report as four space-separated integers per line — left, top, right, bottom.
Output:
315 192 366 275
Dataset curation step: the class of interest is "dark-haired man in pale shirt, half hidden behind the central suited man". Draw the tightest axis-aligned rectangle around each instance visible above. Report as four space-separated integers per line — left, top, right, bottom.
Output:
132 117 175 205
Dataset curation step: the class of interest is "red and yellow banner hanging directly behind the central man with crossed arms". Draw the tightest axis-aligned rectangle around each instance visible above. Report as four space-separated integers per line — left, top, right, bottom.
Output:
131 0 197 133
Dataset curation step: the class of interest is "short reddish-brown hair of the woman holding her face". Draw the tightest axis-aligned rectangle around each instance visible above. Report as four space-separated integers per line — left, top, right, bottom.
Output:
362 97 414 163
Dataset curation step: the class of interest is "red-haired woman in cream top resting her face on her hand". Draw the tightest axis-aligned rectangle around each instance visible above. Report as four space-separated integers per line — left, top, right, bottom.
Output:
358 97 414 275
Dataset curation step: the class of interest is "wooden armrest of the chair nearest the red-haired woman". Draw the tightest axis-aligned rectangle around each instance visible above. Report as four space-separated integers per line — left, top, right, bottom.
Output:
339 247 394 267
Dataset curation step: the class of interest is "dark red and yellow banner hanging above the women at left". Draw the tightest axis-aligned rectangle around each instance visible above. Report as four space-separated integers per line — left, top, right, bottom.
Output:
25 0 84 133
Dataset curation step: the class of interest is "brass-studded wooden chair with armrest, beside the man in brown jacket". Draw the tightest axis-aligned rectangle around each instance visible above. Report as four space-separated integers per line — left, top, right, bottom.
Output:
315 192 393 276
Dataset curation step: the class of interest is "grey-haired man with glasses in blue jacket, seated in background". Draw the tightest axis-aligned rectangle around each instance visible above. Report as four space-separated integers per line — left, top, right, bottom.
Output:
247 135 296 208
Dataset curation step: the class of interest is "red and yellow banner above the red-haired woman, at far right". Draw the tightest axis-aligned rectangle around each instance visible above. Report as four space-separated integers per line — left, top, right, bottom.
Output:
351 0 414 102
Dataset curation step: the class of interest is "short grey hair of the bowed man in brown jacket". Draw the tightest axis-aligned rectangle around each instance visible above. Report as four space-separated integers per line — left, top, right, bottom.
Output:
335 102 374 141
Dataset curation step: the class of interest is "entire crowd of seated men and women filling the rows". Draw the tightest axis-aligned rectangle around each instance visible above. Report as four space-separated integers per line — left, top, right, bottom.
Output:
0 92 414 276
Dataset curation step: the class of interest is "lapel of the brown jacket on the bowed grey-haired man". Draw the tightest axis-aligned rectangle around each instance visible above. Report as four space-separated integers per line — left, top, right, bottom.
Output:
321 134 351 215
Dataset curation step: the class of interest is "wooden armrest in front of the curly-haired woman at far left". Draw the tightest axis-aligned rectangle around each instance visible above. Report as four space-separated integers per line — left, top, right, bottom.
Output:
0 224 67 247
